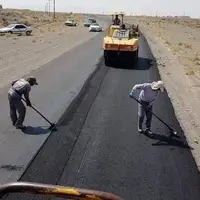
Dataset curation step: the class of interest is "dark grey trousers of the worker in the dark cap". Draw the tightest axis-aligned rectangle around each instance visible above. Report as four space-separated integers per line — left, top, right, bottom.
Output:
8 94 26 126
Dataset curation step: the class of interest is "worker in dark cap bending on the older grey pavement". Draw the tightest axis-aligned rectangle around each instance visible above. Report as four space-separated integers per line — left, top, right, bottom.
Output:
8 77 38 129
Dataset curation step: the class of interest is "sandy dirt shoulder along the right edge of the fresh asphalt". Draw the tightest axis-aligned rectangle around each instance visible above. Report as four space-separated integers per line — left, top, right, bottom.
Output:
126 17 200 169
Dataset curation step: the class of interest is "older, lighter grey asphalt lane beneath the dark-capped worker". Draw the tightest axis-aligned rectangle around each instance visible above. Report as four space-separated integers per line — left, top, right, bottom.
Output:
0 30 104 184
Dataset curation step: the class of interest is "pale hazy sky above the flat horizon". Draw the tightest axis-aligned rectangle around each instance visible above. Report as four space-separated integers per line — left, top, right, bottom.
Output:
0 0 200 18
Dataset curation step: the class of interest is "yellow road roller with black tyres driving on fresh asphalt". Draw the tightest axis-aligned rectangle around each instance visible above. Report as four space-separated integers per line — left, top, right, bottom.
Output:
103 14 139 65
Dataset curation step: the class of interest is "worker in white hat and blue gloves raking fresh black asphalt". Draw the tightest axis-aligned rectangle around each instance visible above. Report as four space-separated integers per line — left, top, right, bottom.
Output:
130 81 164 134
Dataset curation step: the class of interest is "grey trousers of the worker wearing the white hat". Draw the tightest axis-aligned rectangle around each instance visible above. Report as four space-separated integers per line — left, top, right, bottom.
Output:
138 101 153 129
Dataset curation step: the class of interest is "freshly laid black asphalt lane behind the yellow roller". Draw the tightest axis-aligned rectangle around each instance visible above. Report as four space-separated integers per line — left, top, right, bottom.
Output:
3 32 200 200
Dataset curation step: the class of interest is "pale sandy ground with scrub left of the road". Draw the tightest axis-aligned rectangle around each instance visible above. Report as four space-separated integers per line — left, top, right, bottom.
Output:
0 10 106 87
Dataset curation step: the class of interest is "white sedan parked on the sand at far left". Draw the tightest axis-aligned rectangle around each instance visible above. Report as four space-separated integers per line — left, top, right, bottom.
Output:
0 24 32 35
